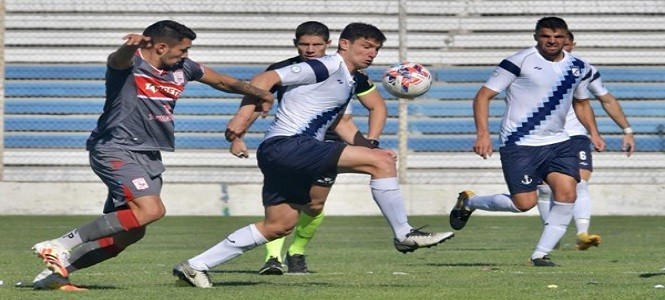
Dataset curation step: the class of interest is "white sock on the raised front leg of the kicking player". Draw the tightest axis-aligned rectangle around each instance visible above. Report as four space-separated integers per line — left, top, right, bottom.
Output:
369 177 413 241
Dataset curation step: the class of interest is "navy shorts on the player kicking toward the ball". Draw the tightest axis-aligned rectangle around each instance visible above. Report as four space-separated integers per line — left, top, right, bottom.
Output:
256 135 346 206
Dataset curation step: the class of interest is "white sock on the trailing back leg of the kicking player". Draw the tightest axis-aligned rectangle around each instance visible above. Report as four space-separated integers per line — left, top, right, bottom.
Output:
188 224 268 271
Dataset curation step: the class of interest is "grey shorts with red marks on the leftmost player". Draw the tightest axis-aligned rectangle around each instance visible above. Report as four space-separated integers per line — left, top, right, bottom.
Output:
89 147 164 213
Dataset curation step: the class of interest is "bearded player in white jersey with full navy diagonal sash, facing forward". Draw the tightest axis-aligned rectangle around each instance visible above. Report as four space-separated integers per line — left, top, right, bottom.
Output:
450 17 605 266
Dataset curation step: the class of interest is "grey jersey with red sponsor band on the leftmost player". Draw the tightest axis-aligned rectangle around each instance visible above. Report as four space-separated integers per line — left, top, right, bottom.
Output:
86 51 203 151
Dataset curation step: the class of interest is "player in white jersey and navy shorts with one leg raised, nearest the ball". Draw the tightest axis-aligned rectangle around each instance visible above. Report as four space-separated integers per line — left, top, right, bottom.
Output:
173 23 453 288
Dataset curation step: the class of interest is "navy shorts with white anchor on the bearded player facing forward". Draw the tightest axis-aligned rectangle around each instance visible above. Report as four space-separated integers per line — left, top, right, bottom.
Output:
499 140 580 195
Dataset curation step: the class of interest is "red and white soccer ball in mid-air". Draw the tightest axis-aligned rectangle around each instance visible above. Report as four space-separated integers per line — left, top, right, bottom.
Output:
381 62 432 99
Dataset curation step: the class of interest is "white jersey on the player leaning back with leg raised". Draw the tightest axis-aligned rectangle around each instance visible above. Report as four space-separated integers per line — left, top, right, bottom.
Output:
265 54 355 141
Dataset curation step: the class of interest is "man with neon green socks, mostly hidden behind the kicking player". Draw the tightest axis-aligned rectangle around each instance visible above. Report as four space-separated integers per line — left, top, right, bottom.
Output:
230 21 388 275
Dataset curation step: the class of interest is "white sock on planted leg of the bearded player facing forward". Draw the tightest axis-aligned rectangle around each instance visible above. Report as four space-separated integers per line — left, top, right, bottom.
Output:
531 201 573 259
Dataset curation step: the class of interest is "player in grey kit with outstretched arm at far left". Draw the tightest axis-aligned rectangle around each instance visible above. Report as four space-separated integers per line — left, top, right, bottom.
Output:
32 20 274 290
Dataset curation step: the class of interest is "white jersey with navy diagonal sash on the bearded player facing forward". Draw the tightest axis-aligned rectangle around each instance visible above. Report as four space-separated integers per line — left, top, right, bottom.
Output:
485 47 591 146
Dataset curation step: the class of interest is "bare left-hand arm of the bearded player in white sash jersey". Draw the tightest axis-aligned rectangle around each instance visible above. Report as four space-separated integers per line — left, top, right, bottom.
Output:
473 86 499 159
